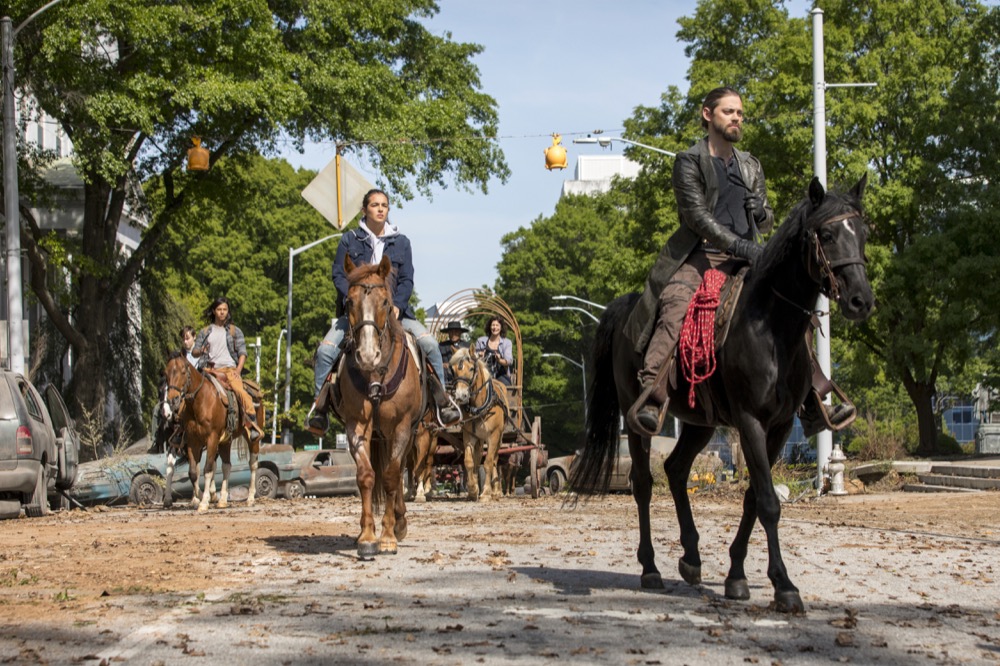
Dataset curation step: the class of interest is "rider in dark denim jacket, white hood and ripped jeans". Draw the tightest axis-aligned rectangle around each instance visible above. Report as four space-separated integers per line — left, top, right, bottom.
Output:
308 189 460 437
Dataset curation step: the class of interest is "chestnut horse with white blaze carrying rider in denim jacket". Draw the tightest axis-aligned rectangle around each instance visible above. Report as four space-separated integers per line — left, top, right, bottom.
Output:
330 256 424 559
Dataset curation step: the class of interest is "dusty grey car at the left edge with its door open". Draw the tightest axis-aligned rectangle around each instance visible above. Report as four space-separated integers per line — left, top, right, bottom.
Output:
0 370 80 518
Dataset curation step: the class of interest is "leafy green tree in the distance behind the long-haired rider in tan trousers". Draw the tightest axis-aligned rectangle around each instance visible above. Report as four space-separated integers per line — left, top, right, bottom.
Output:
145 157 338 436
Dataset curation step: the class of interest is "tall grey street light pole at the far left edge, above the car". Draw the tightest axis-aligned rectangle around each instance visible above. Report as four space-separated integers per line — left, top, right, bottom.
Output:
0 0 68 374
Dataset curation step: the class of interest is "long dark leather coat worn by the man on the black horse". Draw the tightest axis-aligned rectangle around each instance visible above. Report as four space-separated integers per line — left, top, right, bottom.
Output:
625 138 774 354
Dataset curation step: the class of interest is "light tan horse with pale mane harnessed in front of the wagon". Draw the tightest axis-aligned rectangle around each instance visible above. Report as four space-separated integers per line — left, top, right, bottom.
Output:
448 349 510 501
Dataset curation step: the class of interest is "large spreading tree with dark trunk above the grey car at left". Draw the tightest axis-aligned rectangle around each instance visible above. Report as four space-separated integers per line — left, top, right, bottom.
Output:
9 0 508 422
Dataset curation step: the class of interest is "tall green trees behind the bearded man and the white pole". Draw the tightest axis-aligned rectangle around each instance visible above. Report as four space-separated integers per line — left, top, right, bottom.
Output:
627 0 1000 452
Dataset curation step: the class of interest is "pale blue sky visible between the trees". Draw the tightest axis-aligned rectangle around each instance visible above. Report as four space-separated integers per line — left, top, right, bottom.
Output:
276 0 804 307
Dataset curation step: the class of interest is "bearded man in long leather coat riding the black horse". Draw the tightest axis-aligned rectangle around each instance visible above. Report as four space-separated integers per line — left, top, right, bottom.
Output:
624 87 850 436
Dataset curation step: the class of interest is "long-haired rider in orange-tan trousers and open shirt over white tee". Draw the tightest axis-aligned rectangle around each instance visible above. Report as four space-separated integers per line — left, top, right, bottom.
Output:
191 297 264 442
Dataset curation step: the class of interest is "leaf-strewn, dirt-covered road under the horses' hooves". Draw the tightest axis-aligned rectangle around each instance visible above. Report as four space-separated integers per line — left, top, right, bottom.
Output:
0 493 1000 666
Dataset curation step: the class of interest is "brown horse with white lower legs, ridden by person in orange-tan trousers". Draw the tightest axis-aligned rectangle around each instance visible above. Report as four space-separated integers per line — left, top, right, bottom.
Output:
163 352 264 512
